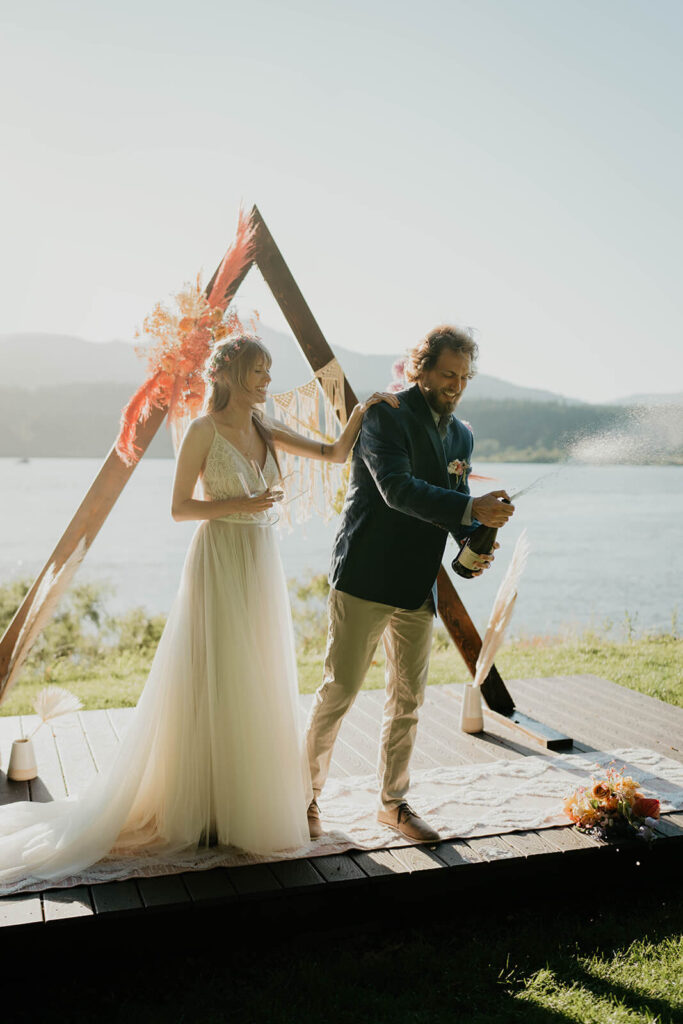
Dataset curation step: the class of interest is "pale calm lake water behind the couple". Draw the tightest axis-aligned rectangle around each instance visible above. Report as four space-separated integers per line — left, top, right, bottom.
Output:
0 459 683 635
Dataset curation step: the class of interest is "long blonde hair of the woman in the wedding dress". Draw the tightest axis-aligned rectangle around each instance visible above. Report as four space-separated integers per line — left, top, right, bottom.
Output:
204 334 280 470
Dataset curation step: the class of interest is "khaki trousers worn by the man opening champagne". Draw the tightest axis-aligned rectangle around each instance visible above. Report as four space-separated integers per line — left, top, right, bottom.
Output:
305 589 434 808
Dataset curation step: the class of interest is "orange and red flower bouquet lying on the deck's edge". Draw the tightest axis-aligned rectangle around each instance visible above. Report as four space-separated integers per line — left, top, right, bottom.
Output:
564 768 659 841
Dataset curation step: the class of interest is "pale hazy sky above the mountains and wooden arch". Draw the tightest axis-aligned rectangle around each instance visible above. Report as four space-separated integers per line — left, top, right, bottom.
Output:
0 0 683 400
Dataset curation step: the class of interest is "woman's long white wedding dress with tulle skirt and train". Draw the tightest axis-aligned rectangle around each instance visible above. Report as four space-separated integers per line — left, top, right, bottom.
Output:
0 419 310 893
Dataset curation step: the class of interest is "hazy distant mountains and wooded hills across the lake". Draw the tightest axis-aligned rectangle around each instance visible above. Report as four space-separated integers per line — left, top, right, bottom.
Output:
0 325 683 461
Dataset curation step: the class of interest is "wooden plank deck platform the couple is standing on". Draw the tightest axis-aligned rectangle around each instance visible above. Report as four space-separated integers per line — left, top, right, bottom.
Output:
0 675 683 941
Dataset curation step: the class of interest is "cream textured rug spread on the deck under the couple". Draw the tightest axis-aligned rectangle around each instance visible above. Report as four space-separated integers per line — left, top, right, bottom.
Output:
0 749 683 894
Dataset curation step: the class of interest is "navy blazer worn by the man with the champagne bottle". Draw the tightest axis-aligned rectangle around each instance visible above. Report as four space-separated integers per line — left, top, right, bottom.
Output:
330 384 478 609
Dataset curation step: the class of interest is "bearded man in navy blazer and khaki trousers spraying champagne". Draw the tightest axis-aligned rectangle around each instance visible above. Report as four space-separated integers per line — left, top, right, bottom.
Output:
305 326 514 842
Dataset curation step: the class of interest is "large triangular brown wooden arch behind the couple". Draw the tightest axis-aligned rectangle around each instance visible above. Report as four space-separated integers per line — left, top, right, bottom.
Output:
0 206 571 749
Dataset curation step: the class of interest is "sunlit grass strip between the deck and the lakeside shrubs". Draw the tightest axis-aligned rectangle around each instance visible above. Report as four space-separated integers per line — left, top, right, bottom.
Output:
0 631 683 715
